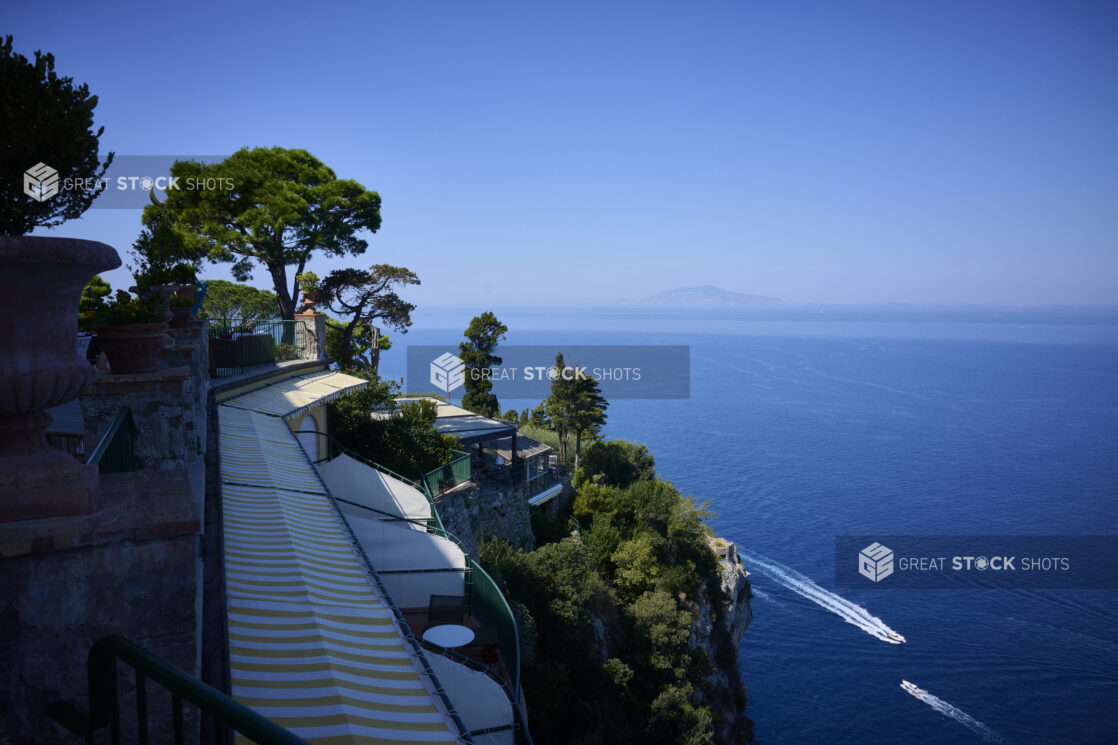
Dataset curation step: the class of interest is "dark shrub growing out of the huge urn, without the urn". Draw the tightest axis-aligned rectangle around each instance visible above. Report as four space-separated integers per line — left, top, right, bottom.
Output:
0 36 113 235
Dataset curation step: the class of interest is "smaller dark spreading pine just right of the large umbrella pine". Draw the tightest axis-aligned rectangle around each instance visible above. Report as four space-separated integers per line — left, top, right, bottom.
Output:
310 264 419 369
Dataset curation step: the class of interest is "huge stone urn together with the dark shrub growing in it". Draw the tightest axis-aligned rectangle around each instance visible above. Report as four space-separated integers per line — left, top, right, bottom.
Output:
0 36 121 521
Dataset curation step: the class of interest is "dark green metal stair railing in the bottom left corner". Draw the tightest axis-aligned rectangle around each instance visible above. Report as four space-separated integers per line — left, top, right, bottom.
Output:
84 635 307 745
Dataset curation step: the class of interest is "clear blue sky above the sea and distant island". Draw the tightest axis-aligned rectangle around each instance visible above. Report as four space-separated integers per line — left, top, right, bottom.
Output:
8 0 1118 305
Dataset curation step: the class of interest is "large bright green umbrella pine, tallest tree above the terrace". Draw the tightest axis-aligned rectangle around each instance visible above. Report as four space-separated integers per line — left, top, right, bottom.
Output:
144 148 380 320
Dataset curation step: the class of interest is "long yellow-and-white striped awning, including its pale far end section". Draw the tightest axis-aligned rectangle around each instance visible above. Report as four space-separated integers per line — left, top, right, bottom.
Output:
218 374 459 745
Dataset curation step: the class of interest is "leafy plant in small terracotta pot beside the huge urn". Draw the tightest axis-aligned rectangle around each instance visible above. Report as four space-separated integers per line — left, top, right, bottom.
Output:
92 290 168 374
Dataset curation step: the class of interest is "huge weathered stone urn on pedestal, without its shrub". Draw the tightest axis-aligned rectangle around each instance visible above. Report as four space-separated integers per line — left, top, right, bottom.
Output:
0 236 121 521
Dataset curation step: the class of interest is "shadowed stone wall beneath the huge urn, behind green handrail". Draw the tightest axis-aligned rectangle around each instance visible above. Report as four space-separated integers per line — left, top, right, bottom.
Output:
0 470 201 745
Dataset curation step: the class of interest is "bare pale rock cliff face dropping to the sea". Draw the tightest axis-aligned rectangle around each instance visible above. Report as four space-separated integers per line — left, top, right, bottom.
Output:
691 537 754 745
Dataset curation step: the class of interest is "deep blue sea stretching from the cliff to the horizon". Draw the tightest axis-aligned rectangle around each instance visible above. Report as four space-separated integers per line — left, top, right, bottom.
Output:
382 309 1118 744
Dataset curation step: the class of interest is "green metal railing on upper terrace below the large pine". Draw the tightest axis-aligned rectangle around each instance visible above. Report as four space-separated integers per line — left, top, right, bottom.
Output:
209 319 310 378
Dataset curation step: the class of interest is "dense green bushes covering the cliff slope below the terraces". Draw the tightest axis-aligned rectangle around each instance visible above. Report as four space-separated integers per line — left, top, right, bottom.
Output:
482 441 726 745
